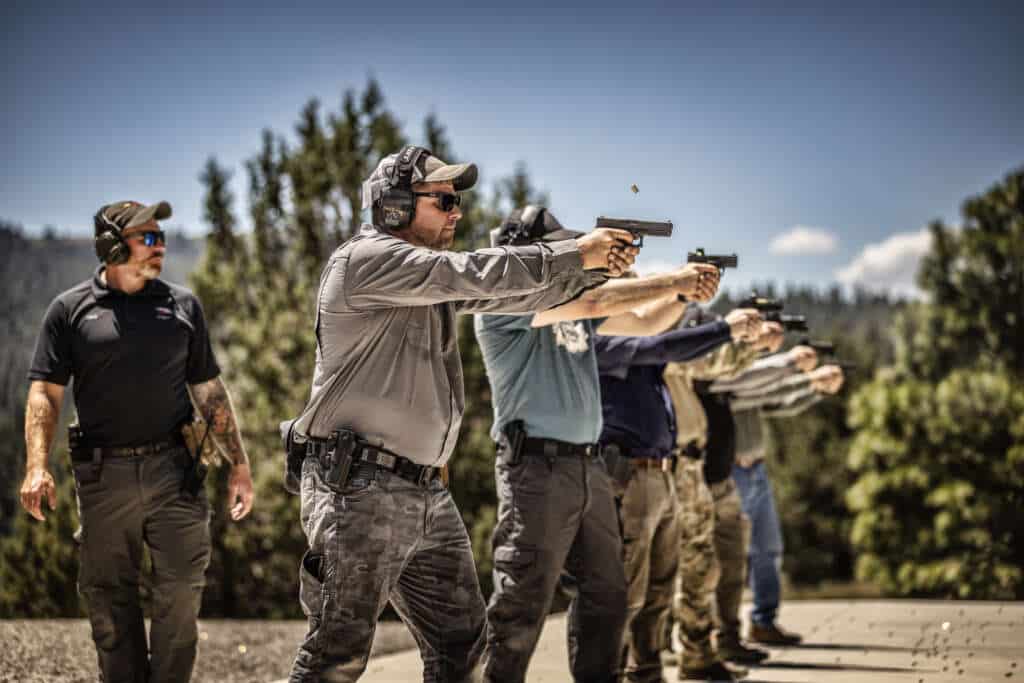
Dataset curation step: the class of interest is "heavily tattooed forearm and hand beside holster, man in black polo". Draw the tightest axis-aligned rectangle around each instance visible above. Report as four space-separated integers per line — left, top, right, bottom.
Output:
188 377 253 521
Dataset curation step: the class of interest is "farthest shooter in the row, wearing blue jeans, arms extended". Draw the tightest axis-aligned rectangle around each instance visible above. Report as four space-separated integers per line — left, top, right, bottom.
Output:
730 358 843 645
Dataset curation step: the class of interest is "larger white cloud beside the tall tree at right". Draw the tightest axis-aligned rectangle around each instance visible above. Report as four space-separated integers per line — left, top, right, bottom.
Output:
836 228 932 298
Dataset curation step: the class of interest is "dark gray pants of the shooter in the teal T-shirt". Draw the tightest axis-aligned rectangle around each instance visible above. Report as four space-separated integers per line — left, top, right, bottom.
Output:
484 449 626 683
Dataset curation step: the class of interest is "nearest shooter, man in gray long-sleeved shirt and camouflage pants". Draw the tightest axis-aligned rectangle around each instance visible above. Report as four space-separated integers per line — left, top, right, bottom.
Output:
290 146 637 682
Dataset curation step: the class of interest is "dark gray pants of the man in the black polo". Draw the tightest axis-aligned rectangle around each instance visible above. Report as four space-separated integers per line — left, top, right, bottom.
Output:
74 447 210 683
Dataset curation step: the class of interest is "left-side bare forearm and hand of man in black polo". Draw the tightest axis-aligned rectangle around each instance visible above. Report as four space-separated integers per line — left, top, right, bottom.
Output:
20 380 65 521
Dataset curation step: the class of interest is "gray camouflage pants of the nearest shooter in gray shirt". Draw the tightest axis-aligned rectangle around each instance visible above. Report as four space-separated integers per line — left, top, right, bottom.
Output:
289 458 485 683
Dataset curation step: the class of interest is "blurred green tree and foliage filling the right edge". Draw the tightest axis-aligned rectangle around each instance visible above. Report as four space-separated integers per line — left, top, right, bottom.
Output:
848 170 1024 599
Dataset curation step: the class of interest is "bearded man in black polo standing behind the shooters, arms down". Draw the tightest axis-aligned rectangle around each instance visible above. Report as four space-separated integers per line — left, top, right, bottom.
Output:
20 202 253 682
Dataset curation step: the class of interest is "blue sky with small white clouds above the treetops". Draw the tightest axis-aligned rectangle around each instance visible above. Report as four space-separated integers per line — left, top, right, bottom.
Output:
0 2 1024 291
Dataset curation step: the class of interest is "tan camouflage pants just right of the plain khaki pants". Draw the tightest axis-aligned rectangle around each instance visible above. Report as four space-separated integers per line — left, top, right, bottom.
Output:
672 458 731 669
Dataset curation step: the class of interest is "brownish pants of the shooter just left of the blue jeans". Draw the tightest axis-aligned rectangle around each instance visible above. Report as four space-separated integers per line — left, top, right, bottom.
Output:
711 477 751 642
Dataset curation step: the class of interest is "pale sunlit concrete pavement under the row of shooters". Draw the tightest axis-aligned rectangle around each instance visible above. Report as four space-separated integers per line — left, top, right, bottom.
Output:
350 600 1024 683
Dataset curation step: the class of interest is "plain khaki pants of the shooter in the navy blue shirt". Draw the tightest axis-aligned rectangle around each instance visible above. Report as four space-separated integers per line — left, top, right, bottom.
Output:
620 469 679 683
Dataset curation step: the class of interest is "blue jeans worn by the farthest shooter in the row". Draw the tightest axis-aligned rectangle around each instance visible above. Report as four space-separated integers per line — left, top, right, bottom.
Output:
732 460 782 626
